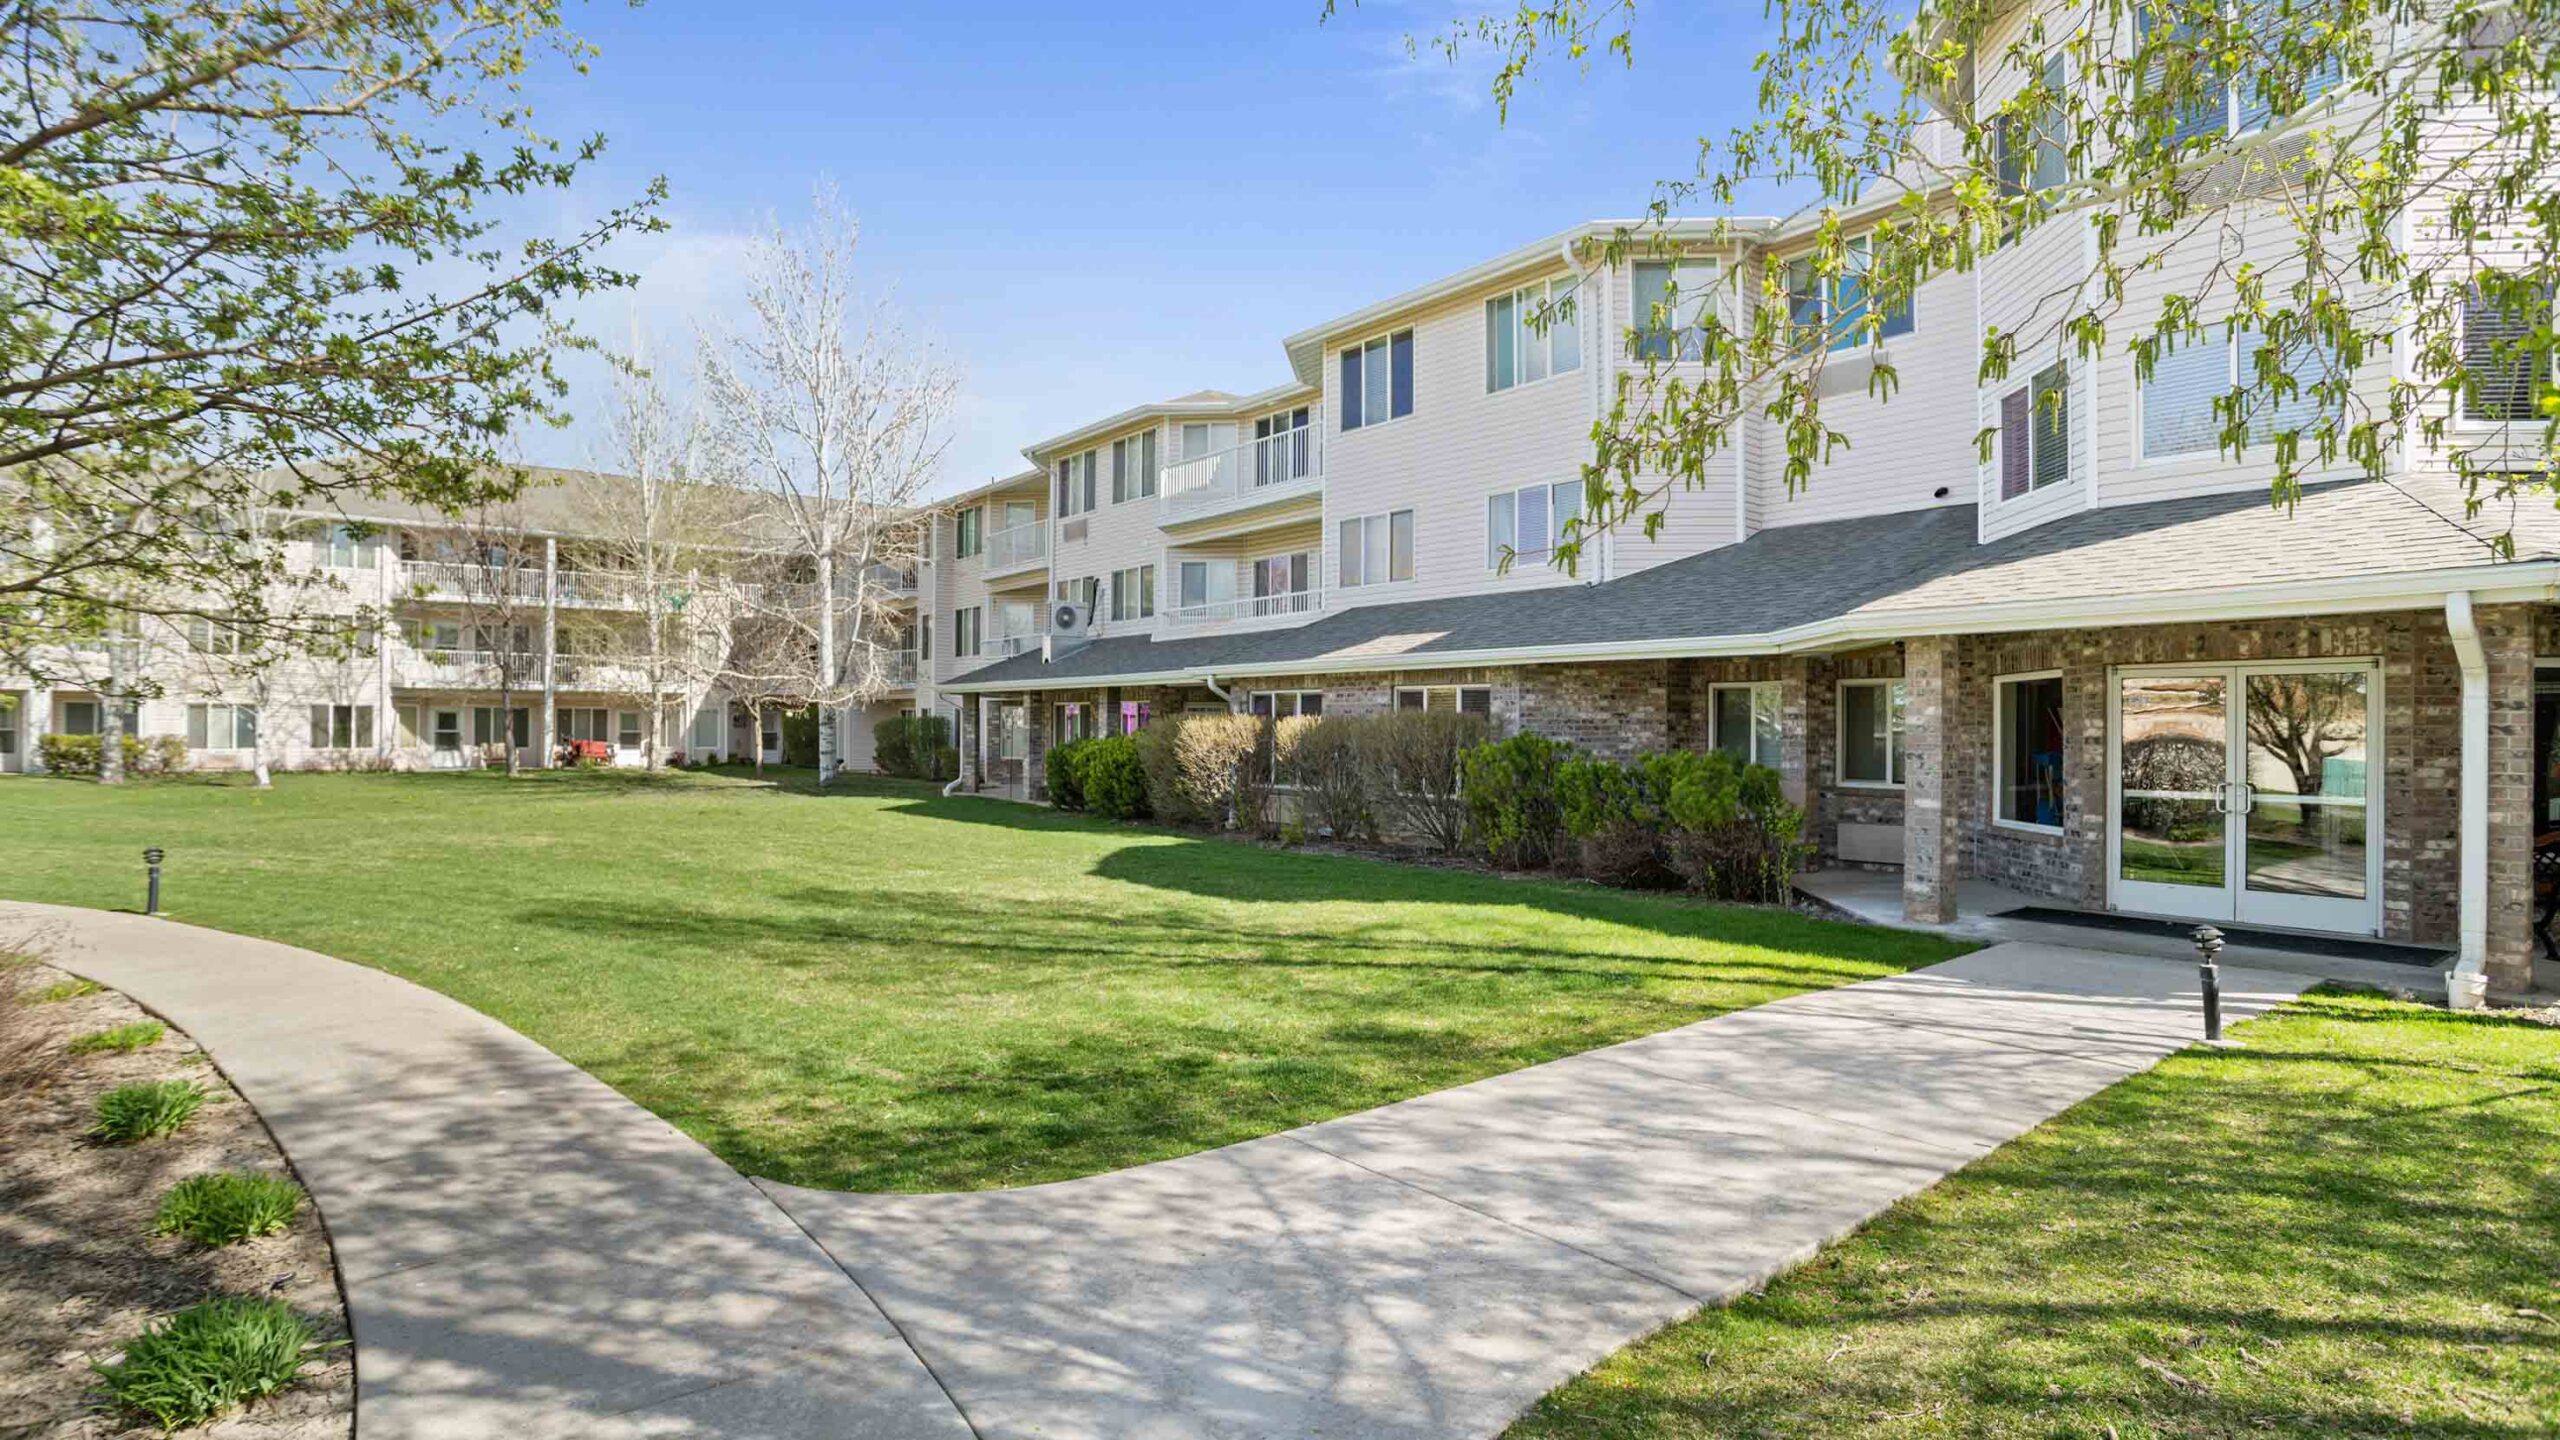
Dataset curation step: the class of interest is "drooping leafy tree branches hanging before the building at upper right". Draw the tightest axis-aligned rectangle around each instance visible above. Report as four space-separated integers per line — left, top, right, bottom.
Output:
1436 0 2560 564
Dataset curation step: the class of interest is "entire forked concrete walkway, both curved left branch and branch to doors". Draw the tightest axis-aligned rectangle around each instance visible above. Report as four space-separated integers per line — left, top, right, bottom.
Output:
0 902 2309 1440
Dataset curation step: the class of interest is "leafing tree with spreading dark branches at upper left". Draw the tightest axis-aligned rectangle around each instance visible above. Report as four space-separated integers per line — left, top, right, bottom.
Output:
0 0 660 682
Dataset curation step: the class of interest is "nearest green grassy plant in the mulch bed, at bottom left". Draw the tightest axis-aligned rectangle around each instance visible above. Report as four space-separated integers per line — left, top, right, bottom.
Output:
95 1294 325 1430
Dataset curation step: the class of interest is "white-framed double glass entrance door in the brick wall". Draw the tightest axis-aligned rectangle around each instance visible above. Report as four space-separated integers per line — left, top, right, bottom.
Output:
2107 661 2381 935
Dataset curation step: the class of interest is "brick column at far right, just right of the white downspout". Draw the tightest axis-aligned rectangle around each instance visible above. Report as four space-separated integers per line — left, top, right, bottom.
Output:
2465 605 2537 997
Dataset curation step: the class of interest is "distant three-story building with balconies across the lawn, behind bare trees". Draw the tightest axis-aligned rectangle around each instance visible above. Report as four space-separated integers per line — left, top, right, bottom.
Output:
0 471 916 771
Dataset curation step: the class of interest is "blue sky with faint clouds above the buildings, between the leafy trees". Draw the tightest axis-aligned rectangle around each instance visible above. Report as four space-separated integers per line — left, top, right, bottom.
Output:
527 0 1766 489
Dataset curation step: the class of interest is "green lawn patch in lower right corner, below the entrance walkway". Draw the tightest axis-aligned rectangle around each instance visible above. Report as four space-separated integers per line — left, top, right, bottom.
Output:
1510 992 2560 1440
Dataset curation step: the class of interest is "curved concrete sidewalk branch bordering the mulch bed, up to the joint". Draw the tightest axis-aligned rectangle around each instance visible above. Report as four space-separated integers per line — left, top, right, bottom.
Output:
0 902 968 1440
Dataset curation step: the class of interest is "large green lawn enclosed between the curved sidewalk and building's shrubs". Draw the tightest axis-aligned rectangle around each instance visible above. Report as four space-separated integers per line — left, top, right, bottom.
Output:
0 774 1956 1189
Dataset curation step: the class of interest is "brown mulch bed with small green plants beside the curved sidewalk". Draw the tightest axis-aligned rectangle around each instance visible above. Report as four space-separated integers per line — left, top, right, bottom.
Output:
0 956 356 1440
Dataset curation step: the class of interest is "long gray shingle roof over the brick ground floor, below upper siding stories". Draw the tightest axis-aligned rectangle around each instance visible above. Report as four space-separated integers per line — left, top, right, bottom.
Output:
952 482 2560 689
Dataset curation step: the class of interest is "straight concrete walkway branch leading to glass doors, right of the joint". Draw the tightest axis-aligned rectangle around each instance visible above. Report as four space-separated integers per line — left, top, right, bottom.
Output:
765 945 2312 1440
